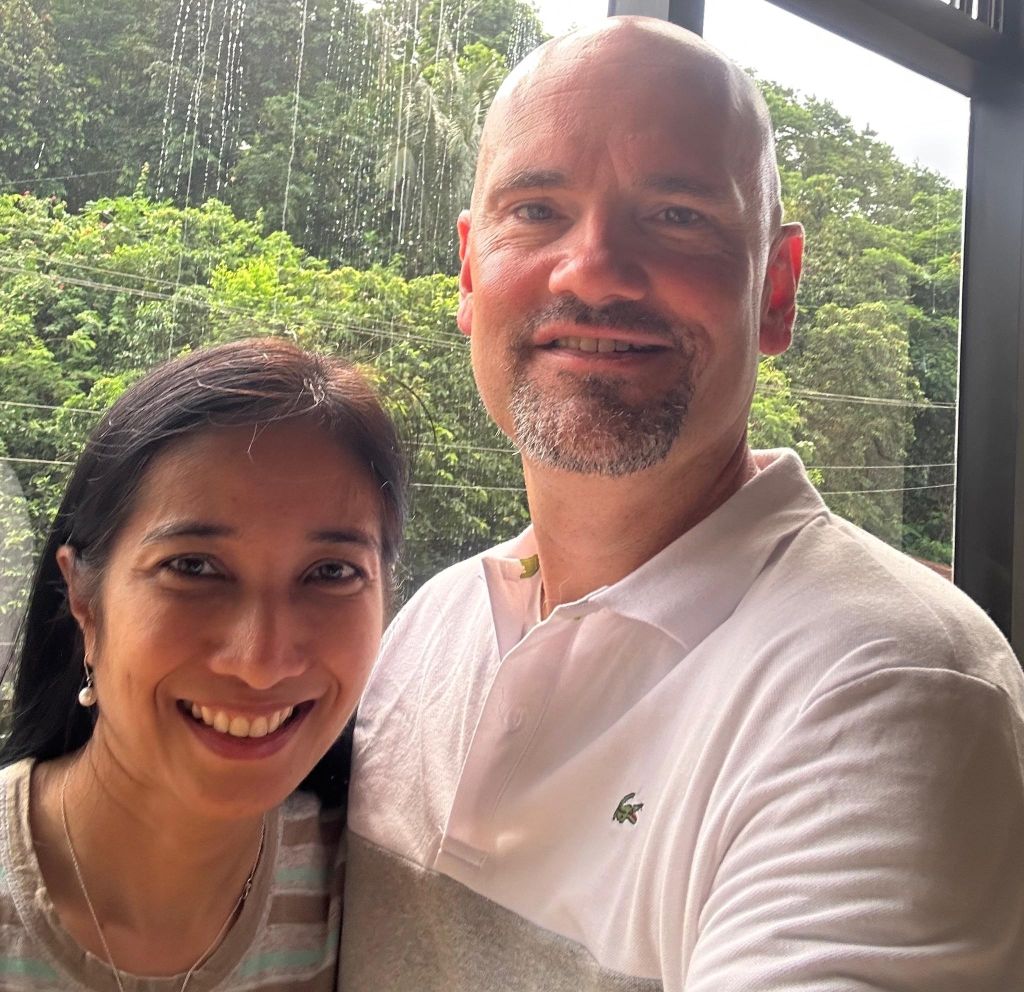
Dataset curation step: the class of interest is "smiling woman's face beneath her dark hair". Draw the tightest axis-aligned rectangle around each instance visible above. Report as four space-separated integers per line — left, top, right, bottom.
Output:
60 421 385 818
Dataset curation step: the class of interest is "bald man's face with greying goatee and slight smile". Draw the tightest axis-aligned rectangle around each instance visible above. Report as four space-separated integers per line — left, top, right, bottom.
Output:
459 46 799 475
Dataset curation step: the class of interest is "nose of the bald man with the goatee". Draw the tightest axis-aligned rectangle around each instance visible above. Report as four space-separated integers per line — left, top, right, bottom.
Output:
548 208 647 306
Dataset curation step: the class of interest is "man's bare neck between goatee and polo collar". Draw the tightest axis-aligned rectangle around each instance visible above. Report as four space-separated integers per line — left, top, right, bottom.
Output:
523 438 757 616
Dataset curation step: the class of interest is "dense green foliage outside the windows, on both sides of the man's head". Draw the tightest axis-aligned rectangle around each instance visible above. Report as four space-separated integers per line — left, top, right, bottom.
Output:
0 0 961 618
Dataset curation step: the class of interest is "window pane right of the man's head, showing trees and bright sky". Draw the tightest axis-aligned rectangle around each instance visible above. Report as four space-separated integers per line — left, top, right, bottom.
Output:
705 0 969 566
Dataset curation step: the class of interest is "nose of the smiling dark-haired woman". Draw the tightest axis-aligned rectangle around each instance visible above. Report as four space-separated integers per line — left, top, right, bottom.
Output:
204 593 308 689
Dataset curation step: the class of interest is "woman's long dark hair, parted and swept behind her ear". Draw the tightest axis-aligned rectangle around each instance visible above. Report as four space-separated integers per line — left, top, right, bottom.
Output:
0 338 407 794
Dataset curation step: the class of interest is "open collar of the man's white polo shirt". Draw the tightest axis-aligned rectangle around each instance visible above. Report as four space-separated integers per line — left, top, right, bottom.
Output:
482 448 828 650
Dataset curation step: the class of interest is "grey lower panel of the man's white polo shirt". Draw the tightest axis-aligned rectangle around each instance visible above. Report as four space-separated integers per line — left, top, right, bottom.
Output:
341 833 663 992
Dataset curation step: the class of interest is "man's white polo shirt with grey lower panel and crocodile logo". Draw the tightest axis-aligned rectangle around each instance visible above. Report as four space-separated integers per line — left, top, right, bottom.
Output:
342 452 1024 992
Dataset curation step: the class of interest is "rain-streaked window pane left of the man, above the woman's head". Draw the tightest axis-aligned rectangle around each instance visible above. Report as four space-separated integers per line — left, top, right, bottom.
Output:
0 0 607 626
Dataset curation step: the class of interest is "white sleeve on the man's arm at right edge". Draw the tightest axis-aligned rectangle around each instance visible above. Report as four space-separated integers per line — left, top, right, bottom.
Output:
682 667 1024 992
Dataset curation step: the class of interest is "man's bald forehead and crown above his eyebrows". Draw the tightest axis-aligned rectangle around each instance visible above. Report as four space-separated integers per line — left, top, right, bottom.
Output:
476 18 771 221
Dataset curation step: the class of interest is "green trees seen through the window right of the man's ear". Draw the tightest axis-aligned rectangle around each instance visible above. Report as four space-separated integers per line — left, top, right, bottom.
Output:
761 83 962 561
